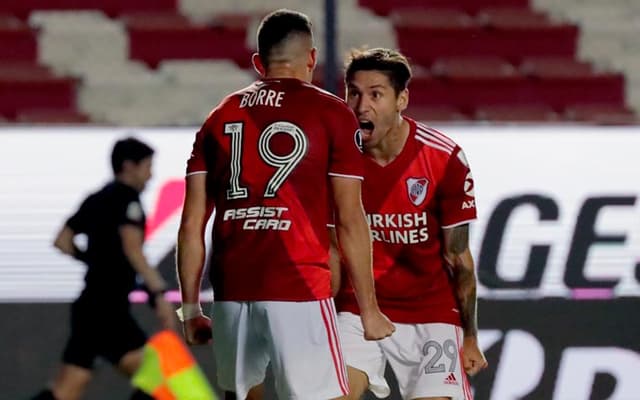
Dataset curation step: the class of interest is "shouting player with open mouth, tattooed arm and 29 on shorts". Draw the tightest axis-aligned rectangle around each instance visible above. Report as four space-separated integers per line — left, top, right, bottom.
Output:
336 49 487 400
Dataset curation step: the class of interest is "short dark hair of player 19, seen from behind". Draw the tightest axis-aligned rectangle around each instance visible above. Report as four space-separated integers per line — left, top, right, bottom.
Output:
258 8 313 67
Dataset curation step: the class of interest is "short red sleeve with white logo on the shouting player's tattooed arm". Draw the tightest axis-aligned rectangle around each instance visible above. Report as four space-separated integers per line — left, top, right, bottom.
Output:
438 147 477 228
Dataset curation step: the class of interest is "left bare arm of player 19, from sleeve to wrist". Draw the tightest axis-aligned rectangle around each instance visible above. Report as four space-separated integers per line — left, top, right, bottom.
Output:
177 174 213 303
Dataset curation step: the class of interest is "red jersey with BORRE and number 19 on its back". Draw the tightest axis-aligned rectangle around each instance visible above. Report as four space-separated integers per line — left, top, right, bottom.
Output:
187 79 363 301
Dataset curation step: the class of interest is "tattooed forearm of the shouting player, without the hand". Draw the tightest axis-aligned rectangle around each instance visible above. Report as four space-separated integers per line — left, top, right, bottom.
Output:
444 224 478 337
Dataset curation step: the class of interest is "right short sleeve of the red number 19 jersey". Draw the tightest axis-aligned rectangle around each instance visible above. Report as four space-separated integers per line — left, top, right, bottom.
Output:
329 105 364 179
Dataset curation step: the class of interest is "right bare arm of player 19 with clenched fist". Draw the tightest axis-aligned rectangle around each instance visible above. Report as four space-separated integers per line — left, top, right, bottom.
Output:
331 176 395 340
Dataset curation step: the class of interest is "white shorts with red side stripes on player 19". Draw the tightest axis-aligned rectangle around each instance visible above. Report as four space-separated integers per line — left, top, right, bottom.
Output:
212 299 349 400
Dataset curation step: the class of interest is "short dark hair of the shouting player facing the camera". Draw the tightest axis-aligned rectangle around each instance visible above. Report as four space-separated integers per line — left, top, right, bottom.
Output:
344 48 411 95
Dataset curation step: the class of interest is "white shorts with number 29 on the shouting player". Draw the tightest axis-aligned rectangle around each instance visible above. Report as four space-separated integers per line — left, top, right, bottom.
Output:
338 312 473 400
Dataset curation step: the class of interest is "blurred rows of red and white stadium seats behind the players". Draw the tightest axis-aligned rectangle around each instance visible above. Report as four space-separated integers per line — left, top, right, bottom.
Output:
0 0 640 125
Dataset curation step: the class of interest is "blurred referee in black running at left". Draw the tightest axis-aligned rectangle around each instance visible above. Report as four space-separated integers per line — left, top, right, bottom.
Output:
34 138 175 400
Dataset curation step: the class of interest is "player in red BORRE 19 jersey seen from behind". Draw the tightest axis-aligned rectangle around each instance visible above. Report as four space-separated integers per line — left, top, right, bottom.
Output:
178 10 394 400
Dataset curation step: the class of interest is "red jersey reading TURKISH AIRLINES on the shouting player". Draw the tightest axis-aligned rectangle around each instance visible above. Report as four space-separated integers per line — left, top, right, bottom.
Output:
337 118 476 325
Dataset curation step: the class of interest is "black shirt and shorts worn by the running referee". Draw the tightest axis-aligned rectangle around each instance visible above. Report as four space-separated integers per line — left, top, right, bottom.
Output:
63 181 146 369
